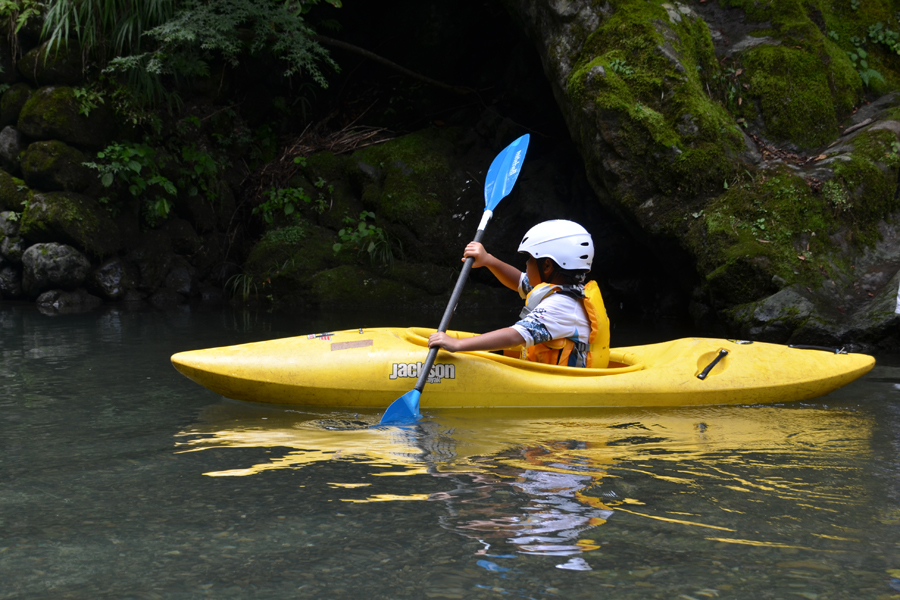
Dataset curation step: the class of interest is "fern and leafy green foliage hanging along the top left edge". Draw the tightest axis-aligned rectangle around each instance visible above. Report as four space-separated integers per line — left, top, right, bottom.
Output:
38 0 341 109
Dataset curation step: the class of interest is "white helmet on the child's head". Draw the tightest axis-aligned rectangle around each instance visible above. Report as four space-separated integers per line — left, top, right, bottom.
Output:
519 220 594 271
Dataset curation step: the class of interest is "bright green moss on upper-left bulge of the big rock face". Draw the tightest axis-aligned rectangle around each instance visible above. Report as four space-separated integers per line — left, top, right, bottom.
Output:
567 0 744 203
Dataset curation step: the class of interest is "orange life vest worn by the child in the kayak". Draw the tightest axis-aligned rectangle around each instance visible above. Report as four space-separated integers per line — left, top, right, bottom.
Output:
523 281 609 369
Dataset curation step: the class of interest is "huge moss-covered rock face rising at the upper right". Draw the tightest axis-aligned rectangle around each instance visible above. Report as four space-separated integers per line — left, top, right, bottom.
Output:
504 0 900 348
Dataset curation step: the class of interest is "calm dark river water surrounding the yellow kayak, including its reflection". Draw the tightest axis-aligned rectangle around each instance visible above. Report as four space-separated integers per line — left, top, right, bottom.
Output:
0 305 900 600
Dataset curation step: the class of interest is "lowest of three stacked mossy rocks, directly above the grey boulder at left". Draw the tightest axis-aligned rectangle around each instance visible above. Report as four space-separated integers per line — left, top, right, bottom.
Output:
19 192 121 258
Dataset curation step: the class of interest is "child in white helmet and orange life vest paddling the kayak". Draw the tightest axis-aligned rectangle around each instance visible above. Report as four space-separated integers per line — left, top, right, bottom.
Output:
428 220 609 368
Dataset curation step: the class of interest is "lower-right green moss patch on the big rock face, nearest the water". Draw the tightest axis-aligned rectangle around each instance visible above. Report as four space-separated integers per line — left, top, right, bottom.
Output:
687 130 900 304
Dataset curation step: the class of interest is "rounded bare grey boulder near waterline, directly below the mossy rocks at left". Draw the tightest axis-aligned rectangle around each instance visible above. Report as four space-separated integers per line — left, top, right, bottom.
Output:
22 243 91 296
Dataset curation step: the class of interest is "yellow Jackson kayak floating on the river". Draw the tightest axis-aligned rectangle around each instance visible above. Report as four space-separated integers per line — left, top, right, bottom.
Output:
172 327 875 410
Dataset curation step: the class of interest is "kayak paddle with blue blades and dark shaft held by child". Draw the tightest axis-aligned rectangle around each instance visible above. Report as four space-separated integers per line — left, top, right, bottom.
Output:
381 134 530 425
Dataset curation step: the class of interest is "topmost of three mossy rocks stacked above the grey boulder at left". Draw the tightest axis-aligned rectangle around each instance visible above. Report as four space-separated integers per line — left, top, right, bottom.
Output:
18 86 116 149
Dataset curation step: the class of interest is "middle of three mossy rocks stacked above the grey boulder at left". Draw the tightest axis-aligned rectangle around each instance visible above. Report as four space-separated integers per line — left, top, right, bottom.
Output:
21 140 95 192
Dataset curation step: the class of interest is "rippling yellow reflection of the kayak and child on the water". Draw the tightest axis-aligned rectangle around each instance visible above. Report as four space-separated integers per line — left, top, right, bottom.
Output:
177 402 872 570
